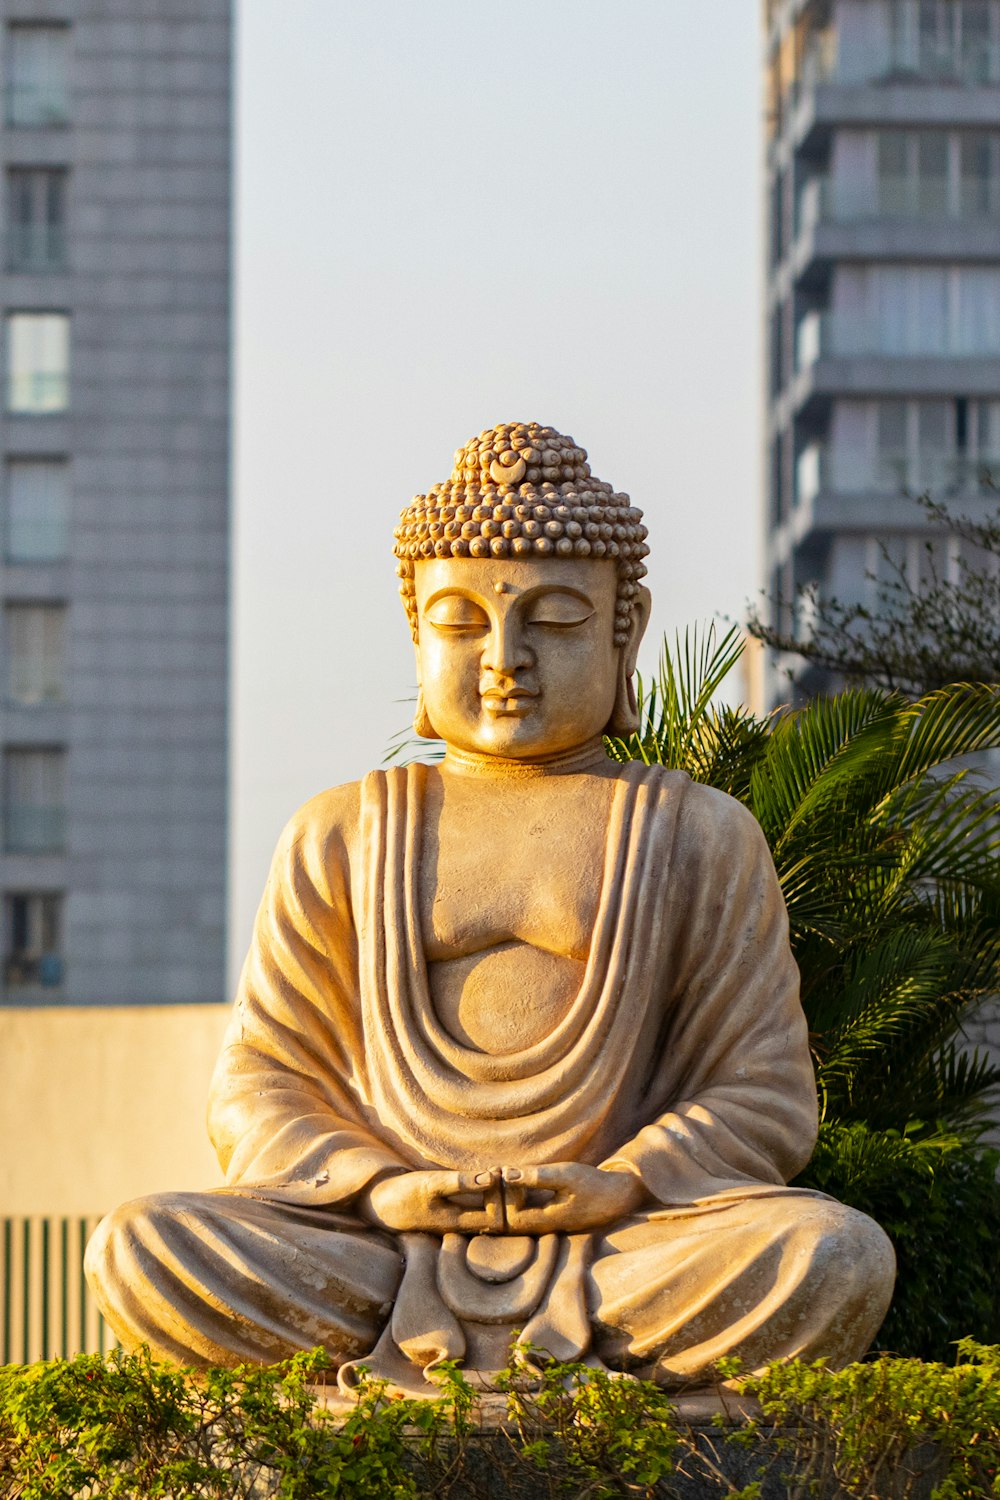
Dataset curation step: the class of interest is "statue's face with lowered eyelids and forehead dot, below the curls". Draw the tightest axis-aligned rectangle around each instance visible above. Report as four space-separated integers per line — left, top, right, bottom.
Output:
414 558 621 759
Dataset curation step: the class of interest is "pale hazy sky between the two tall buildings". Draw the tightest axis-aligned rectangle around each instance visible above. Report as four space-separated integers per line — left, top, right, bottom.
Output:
229 0 763 980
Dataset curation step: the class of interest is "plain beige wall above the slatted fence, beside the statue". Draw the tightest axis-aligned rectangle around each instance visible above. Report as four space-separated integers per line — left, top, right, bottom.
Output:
0 1005 229 1217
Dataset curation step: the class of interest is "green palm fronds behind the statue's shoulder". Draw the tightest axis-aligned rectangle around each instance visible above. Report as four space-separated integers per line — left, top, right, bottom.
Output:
609 630 1000 1133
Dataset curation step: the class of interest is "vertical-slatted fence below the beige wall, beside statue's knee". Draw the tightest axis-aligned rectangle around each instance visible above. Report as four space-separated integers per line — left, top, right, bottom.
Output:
0 1215 118 1365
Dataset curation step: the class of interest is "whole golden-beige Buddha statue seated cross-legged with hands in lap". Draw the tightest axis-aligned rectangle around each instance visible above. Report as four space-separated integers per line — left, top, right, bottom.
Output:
87 423 894 1395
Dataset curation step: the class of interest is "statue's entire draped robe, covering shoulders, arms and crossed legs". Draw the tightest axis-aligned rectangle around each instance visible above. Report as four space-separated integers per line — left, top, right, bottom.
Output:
88 764 892 1388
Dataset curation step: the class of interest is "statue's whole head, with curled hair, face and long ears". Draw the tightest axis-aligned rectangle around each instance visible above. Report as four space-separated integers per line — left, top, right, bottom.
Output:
394 422 649 761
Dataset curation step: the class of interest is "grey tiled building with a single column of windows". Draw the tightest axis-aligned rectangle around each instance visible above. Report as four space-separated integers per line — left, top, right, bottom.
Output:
0 0 231 1005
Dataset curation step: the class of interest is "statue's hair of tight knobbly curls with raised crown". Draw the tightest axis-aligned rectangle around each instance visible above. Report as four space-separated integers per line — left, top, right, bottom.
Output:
393 422 649 647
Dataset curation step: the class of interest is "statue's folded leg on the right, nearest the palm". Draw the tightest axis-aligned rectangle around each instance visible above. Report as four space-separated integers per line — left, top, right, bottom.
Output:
591 1188 895 1386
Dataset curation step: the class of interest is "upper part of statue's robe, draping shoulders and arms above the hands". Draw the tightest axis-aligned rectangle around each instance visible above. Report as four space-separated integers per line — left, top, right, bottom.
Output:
208 764 817 1206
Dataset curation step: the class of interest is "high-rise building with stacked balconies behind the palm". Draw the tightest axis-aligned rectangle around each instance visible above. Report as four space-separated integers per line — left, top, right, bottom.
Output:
765 0 1000 696
